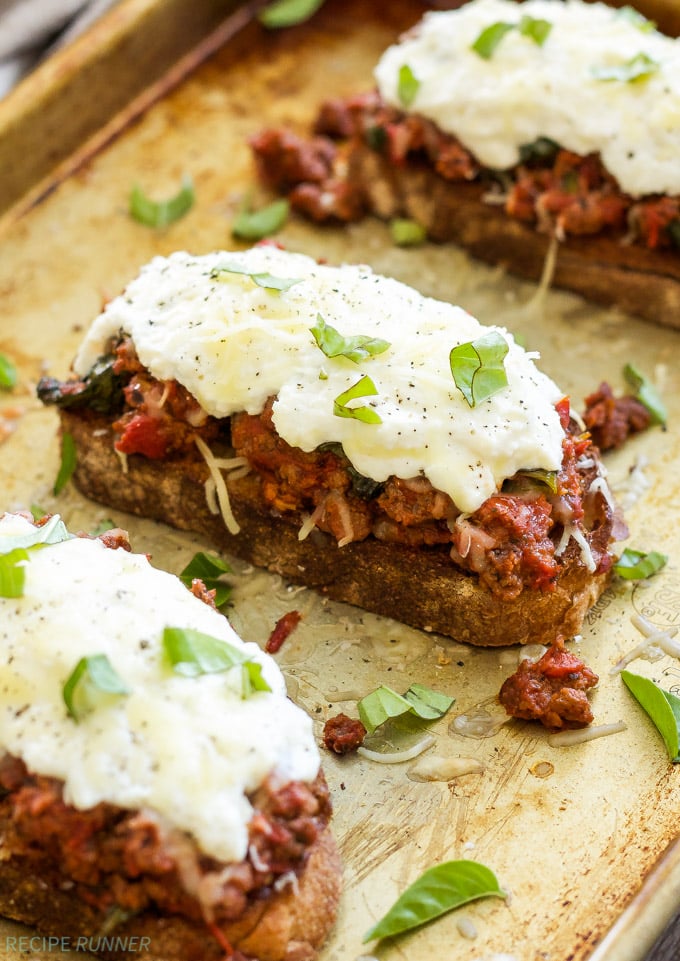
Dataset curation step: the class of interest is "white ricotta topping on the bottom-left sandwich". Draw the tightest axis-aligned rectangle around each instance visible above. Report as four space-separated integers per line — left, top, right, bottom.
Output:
0 515 319 861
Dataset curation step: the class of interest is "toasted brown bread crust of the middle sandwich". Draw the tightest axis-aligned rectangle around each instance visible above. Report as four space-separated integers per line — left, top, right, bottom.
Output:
60 410 609 647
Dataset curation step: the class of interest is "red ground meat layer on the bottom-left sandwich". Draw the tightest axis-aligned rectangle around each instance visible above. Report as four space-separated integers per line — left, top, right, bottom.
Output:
0 755 331 922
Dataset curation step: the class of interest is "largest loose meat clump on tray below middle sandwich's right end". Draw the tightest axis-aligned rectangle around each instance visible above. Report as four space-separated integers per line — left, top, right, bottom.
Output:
499 641 598 730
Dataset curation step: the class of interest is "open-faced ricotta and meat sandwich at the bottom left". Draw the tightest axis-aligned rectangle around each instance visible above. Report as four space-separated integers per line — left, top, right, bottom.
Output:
0 514 340 961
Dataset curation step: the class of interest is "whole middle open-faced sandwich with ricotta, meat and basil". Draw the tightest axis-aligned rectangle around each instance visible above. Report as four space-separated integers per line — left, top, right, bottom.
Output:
39 245 622 645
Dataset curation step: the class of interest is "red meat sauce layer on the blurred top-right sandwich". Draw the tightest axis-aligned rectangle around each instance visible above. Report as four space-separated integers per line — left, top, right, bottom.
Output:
250 92 680 249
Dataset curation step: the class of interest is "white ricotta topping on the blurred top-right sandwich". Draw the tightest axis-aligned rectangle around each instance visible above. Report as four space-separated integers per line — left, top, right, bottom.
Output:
375 0 680 196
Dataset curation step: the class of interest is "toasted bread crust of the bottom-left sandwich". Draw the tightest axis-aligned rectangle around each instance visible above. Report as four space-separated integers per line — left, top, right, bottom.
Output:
0 829 342 961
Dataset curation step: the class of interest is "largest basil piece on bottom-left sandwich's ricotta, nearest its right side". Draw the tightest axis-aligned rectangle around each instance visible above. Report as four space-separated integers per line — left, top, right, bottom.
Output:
163 627 271 697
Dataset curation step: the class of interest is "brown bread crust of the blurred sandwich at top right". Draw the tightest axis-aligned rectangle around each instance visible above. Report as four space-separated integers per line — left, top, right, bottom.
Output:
347 144 680 327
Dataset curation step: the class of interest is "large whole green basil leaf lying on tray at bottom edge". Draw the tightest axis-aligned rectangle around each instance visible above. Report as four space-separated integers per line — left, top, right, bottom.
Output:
362 861 506 944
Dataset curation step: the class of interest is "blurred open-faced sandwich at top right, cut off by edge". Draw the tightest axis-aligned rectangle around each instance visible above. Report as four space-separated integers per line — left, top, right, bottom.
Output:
252 0 680 327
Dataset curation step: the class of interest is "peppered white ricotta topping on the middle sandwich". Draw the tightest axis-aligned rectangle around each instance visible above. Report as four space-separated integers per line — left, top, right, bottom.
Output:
75 246 564 511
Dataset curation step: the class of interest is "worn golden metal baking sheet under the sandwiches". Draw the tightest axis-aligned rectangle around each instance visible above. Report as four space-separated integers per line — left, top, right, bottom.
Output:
0 0 680 961
